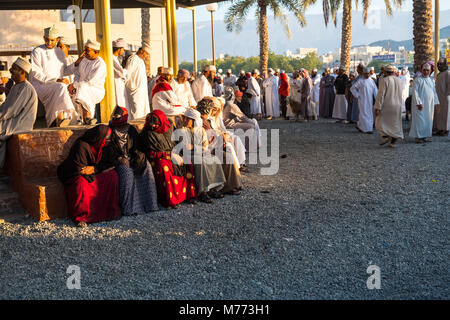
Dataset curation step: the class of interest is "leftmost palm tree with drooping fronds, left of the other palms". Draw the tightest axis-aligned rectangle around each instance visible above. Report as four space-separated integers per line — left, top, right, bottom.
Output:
225 0 306 72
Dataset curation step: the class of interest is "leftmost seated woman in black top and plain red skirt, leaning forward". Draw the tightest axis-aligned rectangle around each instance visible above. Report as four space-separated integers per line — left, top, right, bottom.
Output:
58 125 120 227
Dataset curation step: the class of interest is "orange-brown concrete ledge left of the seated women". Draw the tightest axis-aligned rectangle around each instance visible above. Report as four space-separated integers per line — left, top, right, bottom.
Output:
4 120 144 221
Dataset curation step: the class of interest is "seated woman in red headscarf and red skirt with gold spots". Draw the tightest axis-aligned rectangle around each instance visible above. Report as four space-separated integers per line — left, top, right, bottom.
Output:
140 110 196 209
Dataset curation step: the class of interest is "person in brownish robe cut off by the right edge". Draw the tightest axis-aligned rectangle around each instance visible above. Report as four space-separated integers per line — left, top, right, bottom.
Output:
434 58 450 136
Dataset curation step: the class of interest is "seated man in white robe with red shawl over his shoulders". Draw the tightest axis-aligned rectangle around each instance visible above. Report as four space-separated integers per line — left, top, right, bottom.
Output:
152 68 186 118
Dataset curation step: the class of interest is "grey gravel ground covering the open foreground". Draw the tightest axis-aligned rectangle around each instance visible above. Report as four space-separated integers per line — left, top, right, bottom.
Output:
0 120 450 299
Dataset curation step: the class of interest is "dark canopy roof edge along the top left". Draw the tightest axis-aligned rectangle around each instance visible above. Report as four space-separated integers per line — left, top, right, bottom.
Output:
0 0 225 10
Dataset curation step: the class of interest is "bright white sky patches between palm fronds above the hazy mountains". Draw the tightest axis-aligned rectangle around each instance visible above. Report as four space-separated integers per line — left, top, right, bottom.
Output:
177 0 450 22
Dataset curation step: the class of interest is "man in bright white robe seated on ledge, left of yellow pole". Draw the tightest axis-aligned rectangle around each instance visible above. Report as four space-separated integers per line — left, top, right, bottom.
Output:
30 26 76 127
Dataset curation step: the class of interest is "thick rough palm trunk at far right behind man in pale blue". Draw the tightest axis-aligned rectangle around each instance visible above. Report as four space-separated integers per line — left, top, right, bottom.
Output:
413 0 434 72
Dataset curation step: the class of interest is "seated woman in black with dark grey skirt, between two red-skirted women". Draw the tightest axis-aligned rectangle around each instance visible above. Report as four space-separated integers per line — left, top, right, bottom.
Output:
104 106 158 215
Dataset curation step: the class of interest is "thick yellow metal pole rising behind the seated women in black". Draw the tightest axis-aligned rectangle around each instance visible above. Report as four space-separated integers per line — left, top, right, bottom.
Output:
94 0 116 123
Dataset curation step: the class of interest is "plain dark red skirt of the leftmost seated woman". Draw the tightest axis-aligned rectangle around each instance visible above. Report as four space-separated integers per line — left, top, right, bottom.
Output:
64 170 120 223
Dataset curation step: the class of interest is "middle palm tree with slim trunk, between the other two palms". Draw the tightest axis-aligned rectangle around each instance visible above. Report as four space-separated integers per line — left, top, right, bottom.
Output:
302 0 404 71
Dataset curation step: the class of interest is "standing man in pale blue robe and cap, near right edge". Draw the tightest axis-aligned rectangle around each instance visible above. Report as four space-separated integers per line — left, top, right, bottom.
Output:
409 63 440 143
